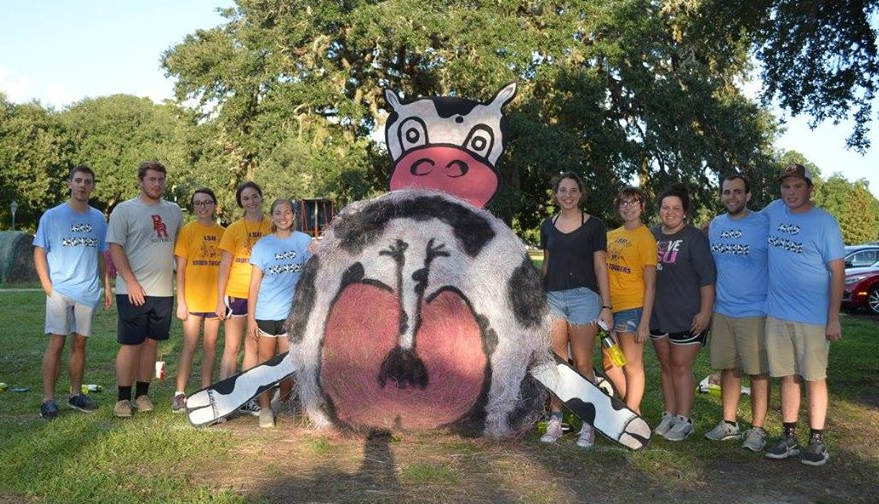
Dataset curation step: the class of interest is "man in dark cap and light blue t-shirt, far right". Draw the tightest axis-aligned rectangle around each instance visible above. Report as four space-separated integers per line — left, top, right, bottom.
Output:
763 164 845 466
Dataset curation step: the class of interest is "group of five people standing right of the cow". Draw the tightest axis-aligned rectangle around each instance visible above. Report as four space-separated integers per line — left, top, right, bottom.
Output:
540 164 845 466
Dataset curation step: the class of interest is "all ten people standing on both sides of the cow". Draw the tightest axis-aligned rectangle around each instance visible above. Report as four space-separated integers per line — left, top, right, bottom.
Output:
34 162 844 465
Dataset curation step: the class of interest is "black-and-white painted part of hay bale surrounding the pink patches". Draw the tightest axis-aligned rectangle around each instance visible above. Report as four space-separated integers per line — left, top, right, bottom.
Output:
288 190 551 435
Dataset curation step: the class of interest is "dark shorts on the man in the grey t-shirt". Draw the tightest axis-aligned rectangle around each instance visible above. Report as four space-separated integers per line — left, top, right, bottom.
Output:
116 294 174 345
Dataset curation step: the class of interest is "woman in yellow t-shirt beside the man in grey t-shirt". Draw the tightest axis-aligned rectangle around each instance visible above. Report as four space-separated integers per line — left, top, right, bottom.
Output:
171 187 224 413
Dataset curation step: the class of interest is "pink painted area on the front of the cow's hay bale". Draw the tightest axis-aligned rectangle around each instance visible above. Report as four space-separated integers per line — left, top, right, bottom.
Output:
321 284 487 430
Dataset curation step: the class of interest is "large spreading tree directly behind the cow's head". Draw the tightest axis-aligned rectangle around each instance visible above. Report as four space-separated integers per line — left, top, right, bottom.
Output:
162 0 773 231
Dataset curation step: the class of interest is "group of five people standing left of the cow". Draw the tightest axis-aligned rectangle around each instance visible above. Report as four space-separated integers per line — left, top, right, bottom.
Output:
34 161 311 427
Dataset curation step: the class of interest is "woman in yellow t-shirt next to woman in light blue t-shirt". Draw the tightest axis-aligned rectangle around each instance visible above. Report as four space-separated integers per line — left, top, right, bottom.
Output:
216 181 272 388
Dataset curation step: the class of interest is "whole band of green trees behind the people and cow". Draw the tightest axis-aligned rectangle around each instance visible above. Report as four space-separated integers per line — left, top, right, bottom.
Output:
0 0 879 241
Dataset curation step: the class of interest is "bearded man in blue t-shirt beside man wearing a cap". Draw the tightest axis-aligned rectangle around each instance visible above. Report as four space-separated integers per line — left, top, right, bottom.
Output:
705 174 769 451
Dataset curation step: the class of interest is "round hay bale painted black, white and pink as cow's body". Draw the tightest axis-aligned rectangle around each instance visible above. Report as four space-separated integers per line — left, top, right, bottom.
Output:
287 190 550 435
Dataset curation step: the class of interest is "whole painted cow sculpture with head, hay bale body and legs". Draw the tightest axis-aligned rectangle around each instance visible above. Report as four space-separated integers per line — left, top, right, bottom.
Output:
187 84 650 449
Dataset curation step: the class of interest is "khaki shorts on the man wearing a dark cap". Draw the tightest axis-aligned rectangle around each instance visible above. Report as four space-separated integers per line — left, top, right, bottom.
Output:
766 317 830 381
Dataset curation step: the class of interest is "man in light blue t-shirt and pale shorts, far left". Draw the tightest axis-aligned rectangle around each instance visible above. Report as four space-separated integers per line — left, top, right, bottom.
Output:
34 165 113 420
